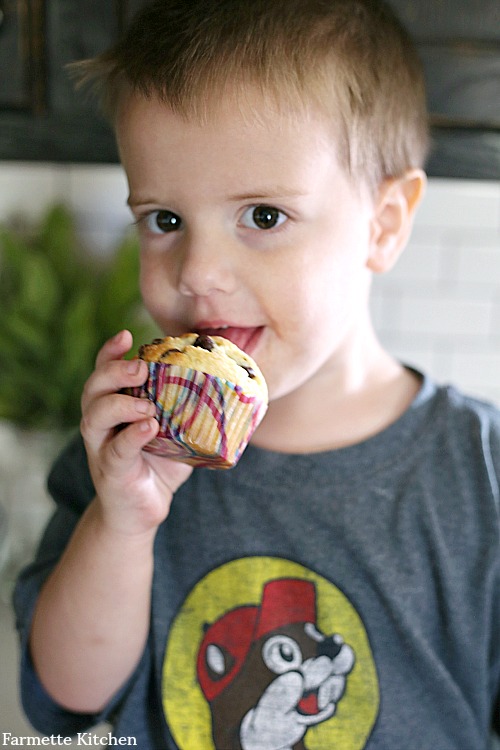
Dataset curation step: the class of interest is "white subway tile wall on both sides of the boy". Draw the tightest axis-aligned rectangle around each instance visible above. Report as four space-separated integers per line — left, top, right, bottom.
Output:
0 162 500 404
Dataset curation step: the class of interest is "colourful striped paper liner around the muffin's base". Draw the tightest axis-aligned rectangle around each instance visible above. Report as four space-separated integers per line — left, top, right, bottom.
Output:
130 362 267 469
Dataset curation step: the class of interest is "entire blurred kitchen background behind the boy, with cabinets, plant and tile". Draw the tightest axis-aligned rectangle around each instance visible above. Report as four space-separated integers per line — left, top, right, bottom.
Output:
0 0 500 736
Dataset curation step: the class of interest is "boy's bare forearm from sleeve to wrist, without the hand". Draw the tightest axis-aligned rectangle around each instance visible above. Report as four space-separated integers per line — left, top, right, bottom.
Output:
30 500 154 714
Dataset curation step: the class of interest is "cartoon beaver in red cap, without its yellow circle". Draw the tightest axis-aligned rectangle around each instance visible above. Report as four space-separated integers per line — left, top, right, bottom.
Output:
193 578 355 750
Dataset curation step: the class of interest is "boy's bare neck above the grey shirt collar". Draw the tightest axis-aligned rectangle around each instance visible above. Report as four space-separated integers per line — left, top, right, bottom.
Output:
252 334 421 453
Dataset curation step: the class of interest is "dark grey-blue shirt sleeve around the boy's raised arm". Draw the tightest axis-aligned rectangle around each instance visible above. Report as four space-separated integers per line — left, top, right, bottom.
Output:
13 437 141 736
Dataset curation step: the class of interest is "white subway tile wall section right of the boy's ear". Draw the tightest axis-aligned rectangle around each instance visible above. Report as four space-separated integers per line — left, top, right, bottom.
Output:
372 179 500 404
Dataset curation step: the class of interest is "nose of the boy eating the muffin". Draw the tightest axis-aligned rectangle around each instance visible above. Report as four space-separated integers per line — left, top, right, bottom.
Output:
178 238 236 297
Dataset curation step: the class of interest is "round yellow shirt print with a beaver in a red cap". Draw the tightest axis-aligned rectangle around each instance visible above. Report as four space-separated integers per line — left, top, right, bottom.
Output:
163 557 379 750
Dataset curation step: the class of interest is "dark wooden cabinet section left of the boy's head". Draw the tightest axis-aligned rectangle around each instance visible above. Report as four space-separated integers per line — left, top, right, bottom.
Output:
0 0 143 162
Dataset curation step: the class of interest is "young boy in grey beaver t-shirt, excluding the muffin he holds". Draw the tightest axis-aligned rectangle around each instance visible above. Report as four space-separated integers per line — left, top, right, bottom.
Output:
16 0 500 750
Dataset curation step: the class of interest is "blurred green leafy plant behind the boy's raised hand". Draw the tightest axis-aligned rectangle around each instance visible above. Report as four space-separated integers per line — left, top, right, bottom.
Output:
0 205 158 430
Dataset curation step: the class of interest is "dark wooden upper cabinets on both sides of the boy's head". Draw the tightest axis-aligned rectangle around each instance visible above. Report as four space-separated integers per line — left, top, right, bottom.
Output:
0 0 500 179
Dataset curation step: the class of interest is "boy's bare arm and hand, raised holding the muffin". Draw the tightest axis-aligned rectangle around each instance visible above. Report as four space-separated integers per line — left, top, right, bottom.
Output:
30 332 192 713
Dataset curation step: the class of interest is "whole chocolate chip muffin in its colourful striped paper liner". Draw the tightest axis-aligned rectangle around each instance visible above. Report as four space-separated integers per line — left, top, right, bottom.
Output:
127 333 267 469
